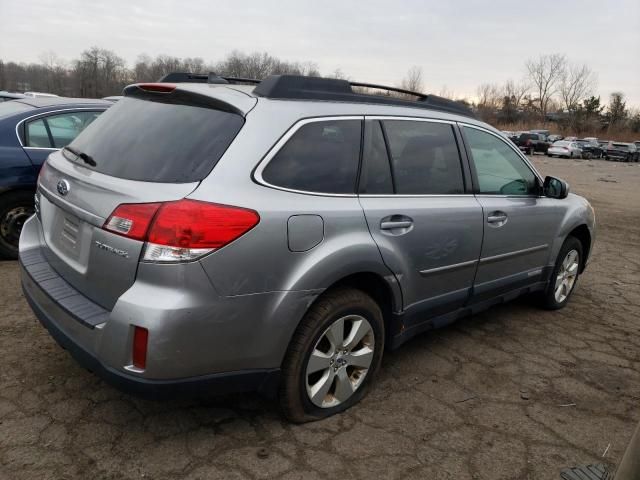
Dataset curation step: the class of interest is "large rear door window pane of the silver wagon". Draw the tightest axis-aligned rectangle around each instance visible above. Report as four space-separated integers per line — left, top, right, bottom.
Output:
383 120 464 195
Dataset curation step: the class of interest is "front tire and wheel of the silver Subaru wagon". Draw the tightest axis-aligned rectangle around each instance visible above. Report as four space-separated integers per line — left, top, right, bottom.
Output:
541 236 584 310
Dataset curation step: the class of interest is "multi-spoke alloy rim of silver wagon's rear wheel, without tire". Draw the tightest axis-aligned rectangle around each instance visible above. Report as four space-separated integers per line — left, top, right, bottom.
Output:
305 315 375 408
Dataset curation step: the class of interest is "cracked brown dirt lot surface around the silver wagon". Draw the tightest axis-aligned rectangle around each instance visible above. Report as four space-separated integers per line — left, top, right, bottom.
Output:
0 156 640 480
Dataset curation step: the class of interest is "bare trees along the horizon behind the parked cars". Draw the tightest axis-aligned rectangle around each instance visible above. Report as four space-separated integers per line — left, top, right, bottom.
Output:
0 47 640 133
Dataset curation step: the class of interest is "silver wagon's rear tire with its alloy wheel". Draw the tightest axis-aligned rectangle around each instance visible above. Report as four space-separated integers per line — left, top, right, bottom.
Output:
278 288 385 423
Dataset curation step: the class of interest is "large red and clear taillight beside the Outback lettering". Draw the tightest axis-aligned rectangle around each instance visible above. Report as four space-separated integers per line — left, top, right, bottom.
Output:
103 199 260 262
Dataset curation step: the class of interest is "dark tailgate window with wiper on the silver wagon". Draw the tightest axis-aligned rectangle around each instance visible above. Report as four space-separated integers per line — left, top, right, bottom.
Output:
69 98 244 183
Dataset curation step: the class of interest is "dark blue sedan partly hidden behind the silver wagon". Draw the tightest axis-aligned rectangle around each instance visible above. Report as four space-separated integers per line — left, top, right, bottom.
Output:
0 97 113 258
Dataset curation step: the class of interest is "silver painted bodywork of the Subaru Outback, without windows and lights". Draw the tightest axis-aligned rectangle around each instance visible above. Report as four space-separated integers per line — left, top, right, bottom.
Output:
20 84 594 379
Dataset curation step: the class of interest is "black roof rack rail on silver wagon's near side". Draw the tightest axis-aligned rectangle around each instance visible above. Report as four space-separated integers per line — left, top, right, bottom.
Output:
253 75 475 118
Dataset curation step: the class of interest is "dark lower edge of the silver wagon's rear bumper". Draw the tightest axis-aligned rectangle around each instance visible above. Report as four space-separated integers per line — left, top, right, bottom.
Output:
20 261 280 398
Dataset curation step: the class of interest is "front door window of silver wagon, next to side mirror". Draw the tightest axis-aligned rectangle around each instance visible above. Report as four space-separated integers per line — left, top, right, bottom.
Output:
465 127 538 195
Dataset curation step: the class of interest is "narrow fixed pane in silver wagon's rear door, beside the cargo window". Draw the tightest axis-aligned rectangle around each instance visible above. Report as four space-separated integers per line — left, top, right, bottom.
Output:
360 121 393 194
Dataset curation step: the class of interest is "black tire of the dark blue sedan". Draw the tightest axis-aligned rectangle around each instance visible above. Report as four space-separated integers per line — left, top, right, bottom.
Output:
0 190 35 260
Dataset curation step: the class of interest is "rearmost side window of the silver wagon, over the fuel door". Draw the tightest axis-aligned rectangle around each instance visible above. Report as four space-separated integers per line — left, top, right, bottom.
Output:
262 120 362 193
